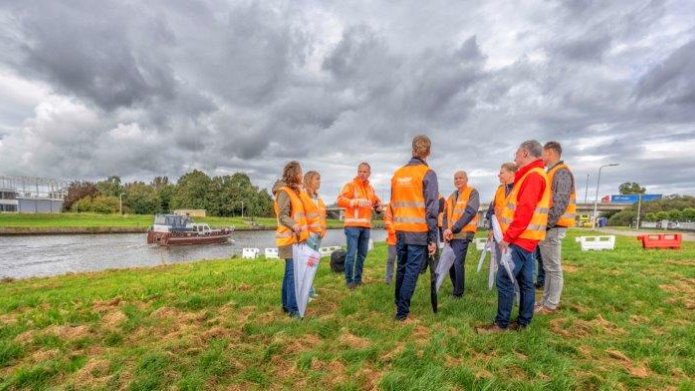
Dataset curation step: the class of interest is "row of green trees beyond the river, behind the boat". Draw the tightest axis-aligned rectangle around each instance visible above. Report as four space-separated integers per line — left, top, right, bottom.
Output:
63 170 273 217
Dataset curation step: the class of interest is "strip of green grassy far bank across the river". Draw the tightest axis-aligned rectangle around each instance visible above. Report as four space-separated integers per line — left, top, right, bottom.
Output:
0 213 383 236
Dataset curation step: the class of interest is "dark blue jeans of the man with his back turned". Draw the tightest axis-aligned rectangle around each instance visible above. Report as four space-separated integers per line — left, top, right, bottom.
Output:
395 233 427 318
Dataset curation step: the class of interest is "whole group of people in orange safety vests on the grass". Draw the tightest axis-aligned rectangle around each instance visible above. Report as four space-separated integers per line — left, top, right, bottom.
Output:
273 135 576 333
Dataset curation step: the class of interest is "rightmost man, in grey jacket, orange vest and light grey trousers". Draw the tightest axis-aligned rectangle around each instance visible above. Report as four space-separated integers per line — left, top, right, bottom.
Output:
534 141 576 314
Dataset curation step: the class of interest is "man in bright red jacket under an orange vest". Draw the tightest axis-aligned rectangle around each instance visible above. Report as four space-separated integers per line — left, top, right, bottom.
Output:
477 140 550 333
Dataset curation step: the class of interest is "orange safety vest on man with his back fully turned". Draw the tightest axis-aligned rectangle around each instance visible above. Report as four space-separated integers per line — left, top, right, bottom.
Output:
390 164 430 232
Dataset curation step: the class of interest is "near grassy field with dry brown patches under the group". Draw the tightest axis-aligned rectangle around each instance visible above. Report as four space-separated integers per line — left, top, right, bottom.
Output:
0 232 695 390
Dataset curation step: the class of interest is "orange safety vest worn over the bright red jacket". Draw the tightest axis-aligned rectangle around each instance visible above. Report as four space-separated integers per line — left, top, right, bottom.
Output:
497 167 550 240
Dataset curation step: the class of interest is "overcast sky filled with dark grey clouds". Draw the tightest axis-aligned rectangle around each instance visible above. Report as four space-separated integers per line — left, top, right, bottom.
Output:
0 0 695 202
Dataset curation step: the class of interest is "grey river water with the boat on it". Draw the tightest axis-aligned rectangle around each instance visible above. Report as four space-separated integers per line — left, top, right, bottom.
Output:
0 229 386 278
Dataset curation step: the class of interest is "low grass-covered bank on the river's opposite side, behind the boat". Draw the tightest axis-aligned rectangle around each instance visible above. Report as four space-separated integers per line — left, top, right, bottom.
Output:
0 213 354 230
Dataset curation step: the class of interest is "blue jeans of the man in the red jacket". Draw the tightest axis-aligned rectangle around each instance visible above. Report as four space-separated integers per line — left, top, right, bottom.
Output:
495 245 536 329
